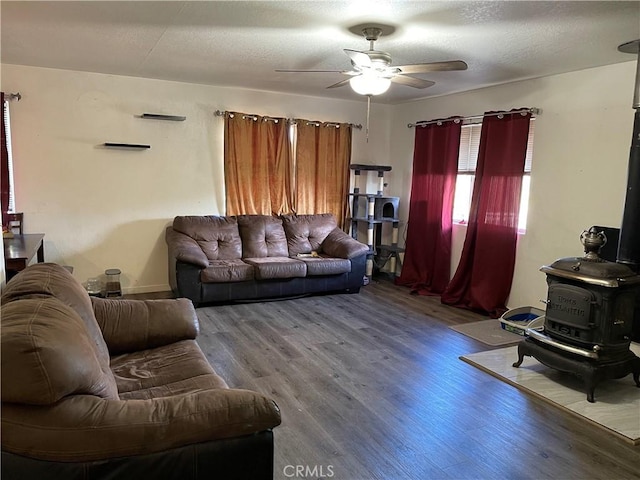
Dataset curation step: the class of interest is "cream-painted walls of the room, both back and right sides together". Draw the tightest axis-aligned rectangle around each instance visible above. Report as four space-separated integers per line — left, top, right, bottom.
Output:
6 61 635 306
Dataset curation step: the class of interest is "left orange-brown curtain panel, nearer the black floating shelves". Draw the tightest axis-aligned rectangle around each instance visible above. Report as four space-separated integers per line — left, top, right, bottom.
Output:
224 112 293 215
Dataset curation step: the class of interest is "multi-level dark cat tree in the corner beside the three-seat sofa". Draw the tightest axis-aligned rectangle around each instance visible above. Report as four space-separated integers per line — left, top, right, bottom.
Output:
349 164 404 278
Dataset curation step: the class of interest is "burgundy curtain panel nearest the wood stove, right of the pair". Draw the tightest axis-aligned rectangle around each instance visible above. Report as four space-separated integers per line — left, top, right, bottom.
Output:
441 112 531 318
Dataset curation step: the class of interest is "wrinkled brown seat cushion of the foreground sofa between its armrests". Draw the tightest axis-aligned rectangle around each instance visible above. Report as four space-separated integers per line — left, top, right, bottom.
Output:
111 340 227 400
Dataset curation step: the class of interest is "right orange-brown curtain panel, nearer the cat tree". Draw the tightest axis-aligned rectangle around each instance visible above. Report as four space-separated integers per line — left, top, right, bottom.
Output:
294 120 351 228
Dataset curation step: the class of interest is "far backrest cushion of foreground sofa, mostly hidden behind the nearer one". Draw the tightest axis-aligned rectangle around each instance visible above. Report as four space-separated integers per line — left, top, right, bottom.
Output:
0 263 111 390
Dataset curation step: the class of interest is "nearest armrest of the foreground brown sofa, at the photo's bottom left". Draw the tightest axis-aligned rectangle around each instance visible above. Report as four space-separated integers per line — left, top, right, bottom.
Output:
2 389 281 462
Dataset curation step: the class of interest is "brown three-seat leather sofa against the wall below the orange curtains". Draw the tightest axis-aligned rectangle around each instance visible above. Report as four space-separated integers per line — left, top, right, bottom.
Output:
166 214 369 306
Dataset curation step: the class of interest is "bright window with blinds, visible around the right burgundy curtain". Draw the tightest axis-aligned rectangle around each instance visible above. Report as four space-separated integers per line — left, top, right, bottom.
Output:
453 118 535 231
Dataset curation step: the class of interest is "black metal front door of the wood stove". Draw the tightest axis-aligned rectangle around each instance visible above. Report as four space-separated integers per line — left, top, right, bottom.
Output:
545 283 600 345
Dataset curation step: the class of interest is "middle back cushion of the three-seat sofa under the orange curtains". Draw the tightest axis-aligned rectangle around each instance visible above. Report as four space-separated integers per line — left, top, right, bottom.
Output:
237 215 289 258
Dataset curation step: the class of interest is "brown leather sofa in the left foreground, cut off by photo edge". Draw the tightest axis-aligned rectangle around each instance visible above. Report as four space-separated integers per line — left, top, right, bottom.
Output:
0 263 280 480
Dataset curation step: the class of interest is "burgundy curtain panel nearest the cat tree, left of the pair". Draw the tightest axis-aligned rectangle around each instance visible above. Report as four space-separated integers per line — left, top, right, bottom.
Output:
396 119 462 295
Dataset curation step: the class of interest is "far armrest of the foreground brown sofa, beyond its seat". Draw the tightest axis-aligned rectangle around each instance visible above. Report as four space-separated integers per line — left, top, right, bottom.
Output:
91 297 199 355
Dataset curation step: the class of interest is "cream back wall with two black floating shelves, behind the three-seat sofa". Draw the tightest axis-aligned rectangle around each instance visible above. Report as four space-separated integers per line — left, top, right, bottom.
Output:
1 65 391 293
